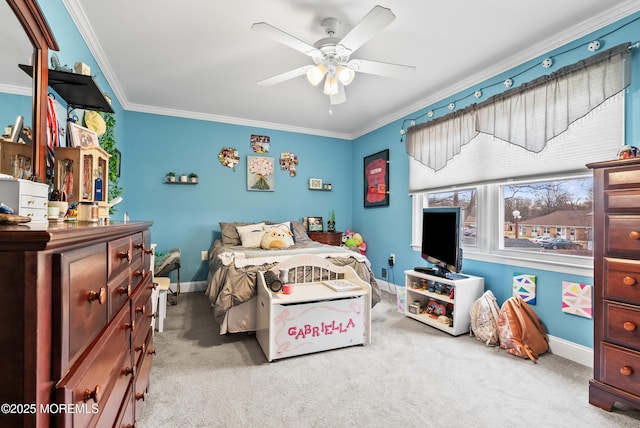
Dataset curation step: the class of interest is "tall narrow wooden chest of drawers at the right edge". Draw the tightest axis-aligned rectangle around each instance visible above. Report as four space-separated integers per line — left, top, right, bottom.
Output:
588 159 640 411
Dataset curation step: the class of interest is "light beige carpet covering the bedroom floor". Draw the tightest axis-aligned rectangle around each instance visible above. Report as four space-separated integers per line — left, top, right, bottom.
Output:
138 293 640 428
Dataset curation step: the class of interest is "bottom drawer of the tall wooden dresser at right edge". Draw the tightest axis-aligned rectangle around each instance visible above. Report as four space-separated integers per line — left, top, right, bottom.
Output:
600 343 640 396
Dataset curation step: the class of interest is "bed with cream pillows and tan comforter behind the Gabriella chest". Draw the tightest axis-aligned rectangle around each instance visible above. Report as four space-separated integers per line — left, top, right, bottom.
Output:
206 221 381 334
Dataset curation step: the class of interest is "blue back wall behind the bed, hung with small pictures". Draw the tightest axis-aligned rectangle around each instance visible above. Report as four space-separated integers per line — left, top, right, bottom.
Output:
123 112 352 281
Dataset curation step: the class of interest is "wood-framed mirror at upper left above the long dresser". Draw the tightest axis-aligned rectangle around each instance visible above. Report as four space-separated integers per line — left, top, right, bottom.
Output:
0 0 58 182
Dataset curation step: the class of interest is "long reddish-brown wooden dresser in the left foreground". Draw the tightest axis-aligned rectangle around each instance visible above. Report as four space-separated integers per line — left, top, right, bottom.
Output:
0 222 155 427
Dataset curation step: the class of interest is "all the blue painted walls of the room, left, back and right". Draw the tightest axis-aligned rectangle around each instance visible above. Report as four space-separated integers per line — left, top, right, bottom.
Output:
5 0 640 346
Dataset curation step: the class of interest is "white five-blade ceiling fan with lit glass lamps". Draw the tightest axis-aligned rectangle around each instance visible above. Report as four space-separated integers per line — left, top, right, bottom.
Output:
251 6 415 105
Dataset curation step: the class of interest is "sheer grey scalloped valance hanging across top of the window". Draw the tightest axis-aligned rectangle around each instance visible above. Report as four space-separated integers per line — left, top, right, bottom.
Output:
406 44 630 192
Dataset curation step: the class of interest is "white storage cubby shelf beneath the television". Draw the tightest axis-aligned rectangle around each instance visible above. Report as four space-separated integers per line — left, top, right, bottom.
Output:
404 270 484 336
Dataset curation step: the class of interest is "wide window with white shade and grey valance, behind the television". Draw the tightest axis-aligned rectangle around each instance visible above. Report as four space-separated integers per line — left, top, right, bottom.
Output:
406 44 630 276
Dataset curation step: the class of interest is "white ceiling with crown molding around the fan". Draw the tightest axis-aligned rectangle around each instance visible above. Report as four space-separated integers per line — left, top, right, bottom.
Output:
0 0 640 139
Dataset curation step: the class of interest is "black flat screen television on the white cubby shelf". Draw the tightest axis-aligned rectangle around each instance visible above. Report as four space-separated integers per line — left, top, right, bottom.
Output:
422 207 464 277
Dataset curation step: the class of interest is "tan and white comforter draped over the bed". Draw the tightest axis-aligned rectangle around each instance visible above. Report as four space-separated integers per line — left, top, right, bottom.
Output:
206 239 381 324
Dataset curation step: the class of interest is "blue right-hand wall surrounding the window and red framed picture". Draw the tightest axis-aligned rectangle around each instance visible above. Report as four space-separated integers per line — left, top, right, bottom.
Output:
353 14 640 347
